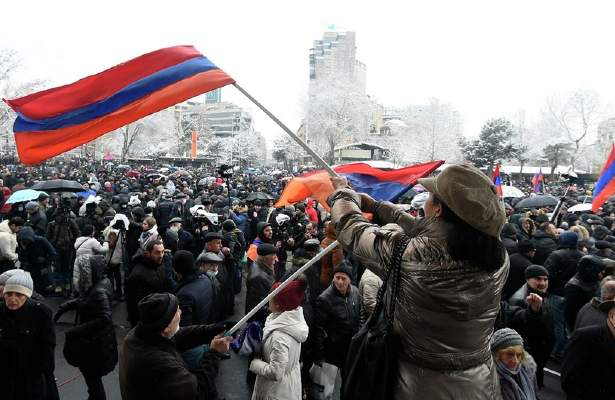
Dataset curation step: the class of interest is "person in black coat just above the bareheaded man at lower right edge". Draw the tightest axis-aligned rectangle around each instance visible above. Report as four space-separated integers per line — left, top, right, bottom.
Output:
564 256 606 332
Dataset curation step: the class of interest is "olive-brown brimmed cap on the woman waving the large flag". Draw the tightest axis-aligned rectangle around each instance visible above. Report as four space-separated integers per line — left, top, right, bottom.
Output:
418 164 506 238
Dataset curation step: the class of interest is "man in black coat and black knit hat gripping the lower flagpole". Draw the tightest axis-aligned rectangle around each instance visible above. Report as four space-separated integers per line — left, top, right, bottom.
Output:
119 293 232 400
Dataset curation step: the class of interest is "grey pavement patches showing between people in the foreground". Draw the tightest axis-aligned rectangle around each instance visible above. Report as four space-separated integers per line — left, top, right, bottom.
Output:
47 287 565 400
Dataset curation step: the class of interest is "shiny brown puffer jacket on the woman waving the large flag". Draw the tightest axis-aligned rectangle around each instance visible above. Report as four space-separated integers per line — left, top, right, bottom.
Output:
330 189 509 400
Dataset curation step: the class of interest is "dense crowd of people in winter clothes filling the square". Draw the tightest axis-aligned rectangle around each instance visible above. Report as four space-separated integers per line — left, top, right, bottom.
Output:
0 160 615 400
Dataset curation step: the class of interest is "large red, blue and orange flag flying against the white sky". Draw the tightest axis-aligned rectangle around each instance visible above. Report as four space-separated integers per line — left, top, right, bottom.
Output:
4 46 235 165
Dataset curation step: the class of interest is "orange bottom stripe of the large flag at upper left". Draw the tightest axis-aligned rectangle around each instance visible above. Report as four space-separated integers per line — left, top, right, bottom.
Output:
15 69 235 165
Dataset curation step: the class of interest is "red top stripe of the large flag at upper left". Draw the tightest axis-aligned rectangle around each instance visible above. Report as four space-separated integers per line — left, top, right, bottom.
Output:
5 46 202 119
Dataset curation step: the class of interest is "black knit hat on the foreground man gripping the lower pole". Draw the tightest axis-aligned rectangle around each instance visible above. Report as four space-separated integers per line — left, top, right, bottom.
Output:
138 293 179 332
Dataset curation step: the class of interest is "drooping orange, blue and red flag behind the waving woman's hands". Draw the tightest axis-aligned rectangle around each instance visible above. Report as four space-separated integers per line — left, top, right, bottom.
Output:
275 161 444 207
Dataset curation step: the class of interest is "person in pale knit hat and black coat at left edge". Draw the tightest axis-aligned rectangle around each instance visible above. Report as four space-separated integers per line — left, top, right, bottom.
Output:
0 273 59 400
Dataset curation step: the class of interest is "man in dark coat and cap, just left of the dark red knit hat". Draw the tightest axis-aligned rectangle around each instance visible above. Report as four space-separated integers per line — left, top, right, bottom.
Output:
245 243 278 325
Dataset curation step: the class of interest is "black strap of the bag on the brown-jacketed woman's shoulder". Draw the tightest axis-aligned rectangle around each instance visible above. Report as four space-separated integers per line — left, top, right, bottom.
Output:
367 233 410 327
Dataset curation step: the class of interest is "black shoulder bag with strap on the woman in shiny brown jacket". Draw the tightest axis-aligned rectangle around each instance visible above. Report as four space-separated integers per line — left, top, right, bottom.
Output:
342 234 410 400
